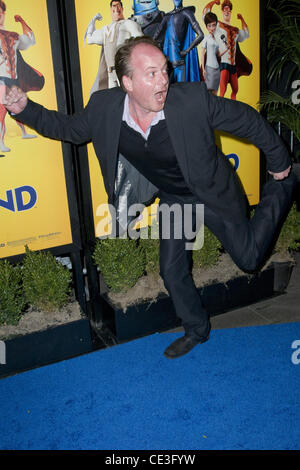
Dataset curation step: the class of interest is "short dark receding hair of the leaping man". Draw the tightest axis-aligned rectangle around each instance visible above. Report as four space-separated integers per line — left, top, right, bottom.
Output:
115 36 162 90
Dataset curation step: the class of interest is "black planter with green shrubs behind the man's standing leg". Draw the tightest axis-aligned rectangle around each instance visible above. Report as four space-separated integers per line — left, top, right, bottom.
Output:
94 223 282 341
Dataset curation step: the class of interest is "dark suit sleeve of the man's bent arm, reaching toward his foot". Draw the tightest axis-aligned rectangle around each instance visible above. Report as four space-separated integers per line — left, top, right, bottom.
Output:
206 93 291 173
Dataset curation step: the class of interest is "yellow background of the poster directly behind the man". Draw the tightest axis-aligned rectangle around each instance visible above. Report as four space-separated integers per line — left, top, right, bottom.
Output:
75 0 260 236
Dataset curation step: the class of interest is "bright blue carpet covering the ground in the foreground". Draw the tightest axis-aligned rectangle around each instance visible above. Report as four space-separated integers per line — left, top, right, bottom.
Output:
0 323 300 450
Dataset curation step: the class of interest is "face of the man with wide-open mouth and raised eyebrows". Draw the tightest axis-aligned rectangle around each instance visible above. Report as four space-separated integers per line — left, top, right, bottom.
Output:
123 44 169 113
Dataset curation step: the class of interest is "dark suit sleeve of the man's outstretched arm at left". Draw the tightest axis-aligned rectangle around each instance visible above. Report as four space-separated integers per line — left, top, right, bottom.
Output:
14 100 92 144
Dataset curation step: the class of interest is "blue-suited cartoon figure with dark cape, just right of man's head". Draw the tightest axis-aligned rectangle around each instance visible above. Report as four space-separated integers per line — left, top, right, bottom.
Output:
153 0 204 82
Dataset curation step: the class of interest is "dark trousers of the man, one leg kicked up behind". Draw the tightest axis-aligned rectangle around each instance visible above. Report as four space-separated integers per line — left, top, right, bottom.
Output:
159 173 297 337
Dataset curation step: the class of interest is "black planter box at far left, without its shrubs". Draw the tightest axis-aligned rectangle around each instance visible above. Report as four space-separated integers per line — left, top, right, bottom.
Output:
0 318 93 378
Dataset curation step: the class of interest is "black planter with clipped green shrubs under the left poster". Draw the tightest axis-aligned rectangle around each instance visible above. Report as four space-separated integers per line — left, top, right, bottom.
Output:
0 248 92 377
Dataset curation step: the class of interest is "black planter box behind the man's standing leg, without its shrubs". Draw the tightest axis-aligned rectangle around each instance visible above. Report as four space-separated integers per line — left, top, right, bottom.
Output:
99 263 292 341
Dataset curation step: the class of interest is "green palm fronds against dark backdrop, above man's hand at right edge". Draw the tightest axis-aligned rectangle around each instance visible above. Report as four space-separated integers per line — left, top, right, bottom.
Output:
260 0 300 160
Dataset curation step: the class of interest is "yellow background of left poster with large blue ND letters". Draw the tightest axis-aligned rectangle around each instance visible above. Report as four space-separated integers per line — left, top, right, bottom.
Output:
0 0 72 258
